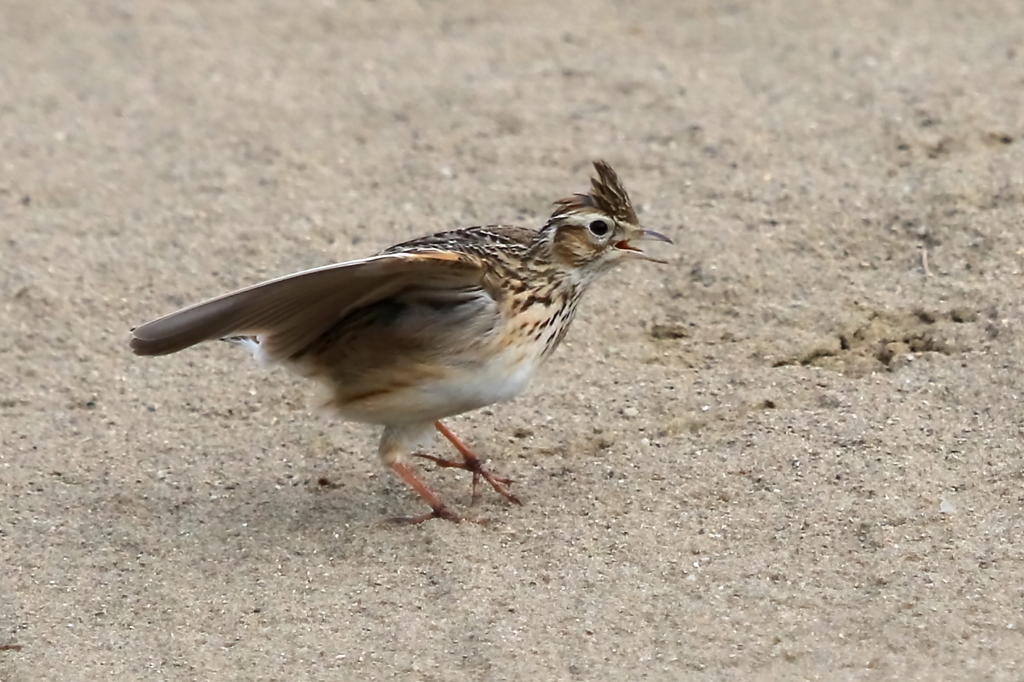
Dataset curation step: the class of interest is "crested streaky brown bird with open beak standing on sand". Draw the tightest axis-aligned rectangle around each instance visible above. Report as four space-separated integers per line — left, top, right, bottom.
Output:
129 161 672 522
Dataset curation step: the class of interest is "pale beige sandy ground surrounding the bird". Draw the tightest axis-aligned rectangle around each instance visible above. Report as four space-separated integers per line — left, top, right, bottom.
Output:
0 0 1024 682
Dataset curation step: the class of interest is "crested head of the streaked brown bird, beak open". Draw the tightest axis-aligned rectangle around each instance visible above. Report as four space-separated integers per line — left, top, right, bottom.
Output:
539 161 672 275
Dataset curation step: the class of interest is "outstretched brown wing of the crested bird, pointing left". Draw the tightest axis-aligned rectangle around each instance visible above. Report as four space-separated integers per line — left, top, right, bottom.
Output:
131 251 485 360
